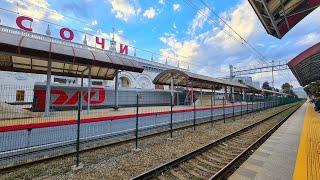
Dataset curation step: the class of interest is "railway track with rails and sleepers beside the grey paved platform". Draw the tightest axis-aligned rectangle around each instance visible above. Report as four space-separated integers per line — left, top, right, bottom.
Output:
133 102 301 180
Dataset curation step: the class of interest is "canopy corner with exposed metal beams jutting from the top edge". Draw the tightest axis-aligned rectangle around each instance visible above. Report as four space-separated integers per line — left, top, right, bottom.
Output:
249 0 320 39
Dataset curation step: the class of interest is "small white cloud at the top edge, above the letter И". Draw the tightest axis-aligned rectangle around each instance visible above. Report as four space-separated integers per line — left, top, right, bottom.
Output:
108 0 141 21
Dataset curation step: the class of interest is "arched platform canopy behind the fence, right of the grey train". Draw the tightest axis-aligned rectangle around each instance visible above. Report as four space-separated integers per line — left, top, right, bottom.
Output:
153 69 248 90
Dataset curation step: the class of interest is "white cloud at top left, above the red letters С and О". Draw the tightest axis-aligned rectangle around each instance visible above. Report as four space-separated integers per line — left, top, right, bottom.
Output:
7 0 64 21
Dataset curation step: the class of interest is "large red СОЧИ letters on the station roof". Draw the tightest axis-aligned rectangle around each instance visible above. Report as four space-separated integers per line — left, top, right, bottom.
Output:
16 16 128 54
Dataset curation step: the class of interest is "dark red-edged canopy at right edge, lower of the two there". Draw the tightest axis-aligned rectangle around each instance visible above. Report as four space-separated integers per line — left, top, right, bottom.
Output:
288 42 320 86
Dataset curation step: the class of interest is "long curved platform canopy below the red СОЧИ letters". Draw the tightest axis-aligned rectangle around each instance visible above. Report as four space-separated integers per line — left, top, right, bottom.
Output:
0 26 143 80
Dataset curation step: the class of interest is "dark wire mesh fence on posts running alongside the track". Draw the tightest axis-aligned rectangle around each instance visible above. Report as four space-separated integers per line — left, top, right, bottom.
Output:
0 85 297 168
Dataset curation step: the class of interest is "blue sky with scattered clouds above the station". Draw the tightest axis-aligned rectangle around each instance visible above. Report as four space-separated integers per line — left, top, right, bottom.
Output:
0 0 320 88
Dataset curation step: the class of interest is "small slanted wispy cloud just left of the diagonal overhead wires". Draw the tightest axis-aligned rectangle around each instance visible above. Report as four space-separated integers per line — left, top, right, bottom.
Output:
187 8 210 36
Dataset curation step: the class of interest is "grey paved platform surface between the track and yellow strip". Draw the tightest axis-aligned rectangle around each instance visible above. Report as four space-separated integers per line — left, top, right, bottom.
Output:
229 103 307 180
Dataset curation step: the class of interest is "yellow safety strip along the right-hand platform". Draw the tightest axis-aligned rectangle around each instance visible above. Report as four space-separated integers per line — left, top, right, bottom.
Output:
292 104 320 180
